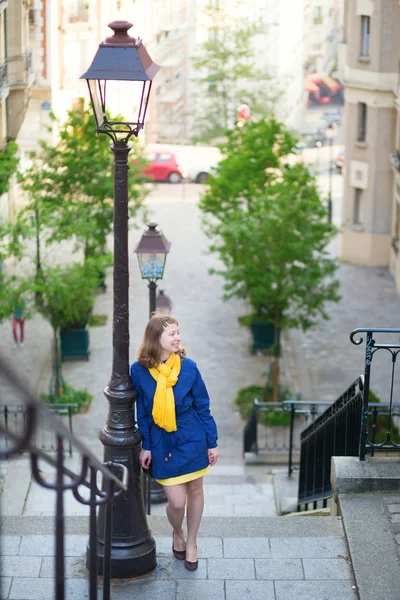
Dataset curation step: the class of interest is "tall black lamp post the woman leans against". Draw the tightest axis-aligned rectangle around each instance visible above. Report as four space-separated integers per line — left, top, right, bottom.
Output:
81 21 159 578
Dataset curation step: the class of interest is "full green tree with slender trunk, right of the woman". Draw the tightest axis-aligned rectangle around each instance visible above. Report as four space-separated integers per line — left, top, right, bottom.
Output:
200 120 339 402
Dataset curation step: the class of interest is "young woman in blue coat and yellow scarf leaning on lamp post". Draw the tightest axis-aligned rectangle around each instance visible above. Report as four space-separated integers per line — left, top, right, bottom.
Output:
131 315 218 571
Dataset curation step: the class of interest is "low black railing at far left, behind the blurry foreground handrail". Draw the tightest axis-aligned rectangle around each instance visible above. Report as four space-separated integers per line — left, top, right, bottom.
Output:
0 404 78 456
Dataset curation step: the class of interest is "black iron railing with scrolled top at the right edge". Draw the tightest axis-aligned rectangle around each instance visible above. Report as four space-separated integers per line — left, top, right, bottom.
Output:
350 328 400 460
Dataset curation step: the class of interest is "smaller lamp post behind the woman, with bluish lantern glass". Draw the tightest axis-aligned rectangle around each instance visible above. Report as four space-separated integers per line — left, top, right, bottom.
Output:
134 223 171 504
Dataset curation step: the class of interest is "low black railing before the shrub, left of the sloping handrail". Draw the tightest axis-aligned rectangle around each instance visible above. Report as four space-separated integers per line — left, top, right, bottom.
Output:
243 399 331 476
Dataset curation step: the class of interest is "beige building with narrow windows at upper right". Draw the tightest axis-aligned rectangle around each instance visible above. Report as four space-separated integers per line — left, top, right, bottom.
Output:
339 0 400 272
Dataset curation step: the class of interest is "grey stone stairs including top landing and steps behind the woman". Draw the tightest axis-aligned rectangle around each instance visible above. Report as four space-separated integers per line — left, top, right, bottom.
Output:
0 457 356 600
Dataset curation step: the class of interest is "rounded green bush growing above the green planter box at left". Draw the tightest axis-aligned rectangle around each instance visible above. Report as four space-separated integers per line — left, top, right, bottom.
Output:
35 260 98 330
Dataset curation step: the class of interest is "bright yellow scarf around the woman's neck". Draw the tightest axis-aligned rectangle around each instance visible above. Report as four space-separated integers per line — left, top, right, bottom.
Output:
149 352 181 431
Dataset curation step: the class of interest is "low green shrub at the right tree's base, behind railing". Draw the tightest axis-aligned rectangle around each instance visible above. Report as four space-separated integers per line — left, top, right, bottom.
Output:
235 384 292 427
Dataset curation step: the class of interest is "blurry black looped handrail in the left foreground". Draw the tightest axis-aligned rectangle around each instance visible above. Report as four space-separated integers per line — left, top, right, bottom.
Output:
0 359 128 600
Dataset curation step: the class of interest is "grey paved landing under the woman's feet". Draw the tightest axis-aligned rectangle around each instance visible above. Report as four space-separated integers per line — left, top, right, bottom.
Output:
2 517 356 600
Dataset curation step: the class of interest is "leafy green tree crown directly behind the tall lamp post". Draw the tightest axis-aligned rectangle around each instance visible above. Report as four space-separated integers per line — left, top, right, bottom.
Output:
19 100 145 258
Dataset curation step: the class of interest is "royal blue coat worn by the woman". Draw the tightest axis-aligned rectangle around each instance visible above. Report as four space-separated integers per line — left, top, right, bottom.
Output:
131 358 218 479
